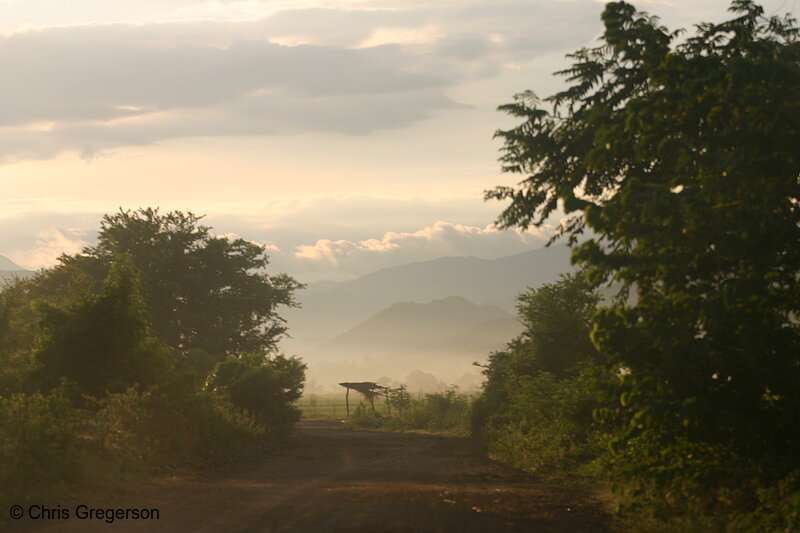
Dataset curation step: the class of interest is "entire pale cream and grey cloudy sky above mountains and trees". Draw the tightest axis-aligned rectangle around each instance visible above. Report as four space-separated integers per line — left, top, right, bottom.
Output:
0 0 798 281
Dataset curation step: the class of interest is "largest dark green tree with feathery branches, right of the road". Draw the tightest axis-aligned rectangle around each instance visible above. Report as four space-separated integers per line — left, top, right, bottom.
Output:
487 0 800 468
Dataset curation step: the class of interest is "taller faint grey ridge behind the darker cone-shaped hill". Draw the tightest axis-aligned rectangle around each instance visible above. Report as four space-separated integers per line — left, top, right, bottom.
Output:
283 246 572 355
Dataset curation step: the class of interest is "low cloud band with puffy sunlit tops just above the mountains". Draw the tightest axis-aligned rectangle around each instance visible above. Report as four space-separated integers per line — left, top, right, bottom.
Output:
0 193 558 282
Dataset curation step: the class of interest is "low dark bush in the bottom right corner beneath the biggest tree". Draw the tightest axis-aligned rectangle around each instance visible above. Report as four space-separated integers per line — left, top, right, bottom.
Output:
603 436 800 533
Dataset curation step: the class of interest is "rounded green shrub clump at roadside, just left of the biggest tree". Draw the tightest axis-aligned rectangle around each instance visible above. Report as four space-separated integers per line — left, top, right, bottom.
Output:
471 273 609 473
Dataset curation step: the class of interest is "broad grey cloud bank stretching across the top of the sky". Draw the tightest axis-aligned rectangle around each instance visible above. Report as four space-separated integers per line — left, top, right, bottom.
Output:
0 0 600 161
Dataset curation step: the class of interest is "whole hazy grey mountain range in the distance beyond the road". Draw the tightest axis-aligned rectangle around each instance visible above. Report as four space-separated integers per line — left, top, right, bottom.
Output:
282 246 573 390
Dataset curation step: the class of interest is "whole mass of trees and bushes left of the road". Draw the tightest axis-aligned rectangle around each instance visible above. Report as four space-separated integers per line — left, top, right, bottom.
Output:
0 209 305 502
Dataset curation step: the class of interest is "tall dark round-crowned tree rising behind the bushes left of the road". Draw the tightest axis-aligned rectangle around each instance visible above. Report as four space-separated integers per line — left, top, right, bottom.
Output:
67 208 301 361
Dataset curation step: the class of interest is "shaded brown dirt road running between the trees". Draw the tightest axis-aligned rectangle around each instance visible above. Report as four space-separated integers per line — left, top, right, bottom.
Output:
6 421 608 533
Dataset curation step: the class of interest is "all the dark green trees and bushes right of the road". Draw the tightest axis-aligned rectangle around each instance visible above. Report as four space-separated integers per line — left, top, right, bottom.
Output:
356 0 800 533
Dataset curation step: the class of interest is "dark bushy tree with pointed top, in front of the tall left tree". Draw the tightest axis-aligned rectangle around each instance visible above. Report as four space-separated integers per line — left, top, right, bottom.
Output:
34 256 169 397
